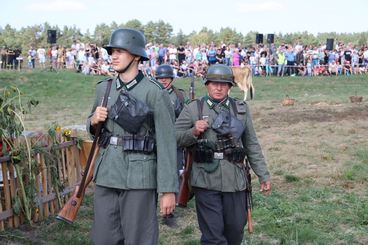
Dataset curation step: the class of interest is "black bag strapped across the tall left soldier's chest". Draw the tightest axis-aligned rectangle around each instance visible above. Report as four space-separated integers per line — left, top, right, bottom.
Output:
109 90 152 134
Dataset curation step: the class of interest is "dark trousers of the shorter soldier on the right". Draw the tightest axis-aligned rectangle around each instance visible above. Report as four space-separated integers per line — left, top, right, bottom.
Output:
193 187 247 245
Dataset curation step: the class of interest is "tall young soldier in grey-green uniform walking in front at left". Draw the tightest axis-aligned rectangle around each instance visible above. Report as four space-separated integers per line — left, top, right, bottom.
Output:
87 29 178 245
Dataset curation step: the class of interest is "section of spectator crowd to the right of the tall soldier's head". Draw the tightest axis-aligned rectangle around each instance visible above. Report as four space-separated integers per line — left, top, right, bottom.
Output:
142 42 368 77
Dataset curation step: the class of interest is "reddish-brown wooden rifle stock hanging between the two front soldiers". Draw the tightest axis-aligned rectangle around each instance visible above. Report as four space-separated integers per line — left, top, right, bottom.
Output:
178 150 193 207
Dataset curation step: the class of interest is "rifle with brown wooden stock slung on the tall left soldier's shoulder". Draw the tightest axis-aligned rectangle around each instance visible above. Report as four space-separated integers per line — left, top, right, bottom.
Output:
56 79 112 224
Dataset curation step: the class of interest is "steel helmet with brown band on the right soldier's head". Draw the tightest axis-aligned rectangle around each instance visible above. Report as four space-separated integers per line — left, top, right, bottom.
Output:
204 64 234 85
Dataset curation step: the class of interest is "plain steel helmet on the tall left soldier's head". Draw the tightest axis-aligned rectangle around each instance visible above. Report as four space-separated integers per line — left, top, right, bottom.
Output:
104 28 149 60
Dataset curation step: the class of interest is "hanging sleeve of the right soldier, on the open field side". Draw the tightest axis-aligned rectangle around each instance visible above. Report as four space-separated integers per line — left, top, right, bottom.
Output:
242 102 270 182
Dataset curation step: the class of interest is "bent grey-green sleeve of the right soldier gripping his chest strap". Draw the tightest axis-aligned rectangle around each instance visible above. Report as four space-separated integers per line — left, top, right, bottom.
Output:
175 102 198 148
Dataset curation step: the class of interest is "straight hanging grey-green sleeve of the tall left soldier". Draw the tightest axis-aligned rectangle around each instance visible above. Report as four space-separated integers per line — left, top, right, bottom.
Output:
154 90 179 193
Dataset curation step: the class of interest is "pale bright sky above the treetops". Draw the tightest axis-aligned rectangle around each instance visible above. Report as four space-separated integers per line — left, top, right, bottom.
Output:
0 0 368 35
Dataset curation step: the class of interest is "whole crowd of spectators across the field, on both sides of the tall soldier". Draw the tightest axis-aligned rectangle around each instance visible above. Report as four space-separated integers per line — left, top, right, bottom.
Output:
2 40 368 77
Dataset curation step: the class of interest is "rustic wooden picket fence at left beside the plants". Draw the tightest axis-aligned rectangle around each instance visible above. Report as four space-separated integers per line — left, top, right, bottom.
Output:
0 135 92 231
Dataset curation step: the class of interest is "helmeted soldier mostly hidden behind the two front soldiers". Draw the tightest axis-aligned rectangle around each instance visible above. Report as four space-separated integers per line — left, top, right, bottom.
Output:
155 64 188 227
